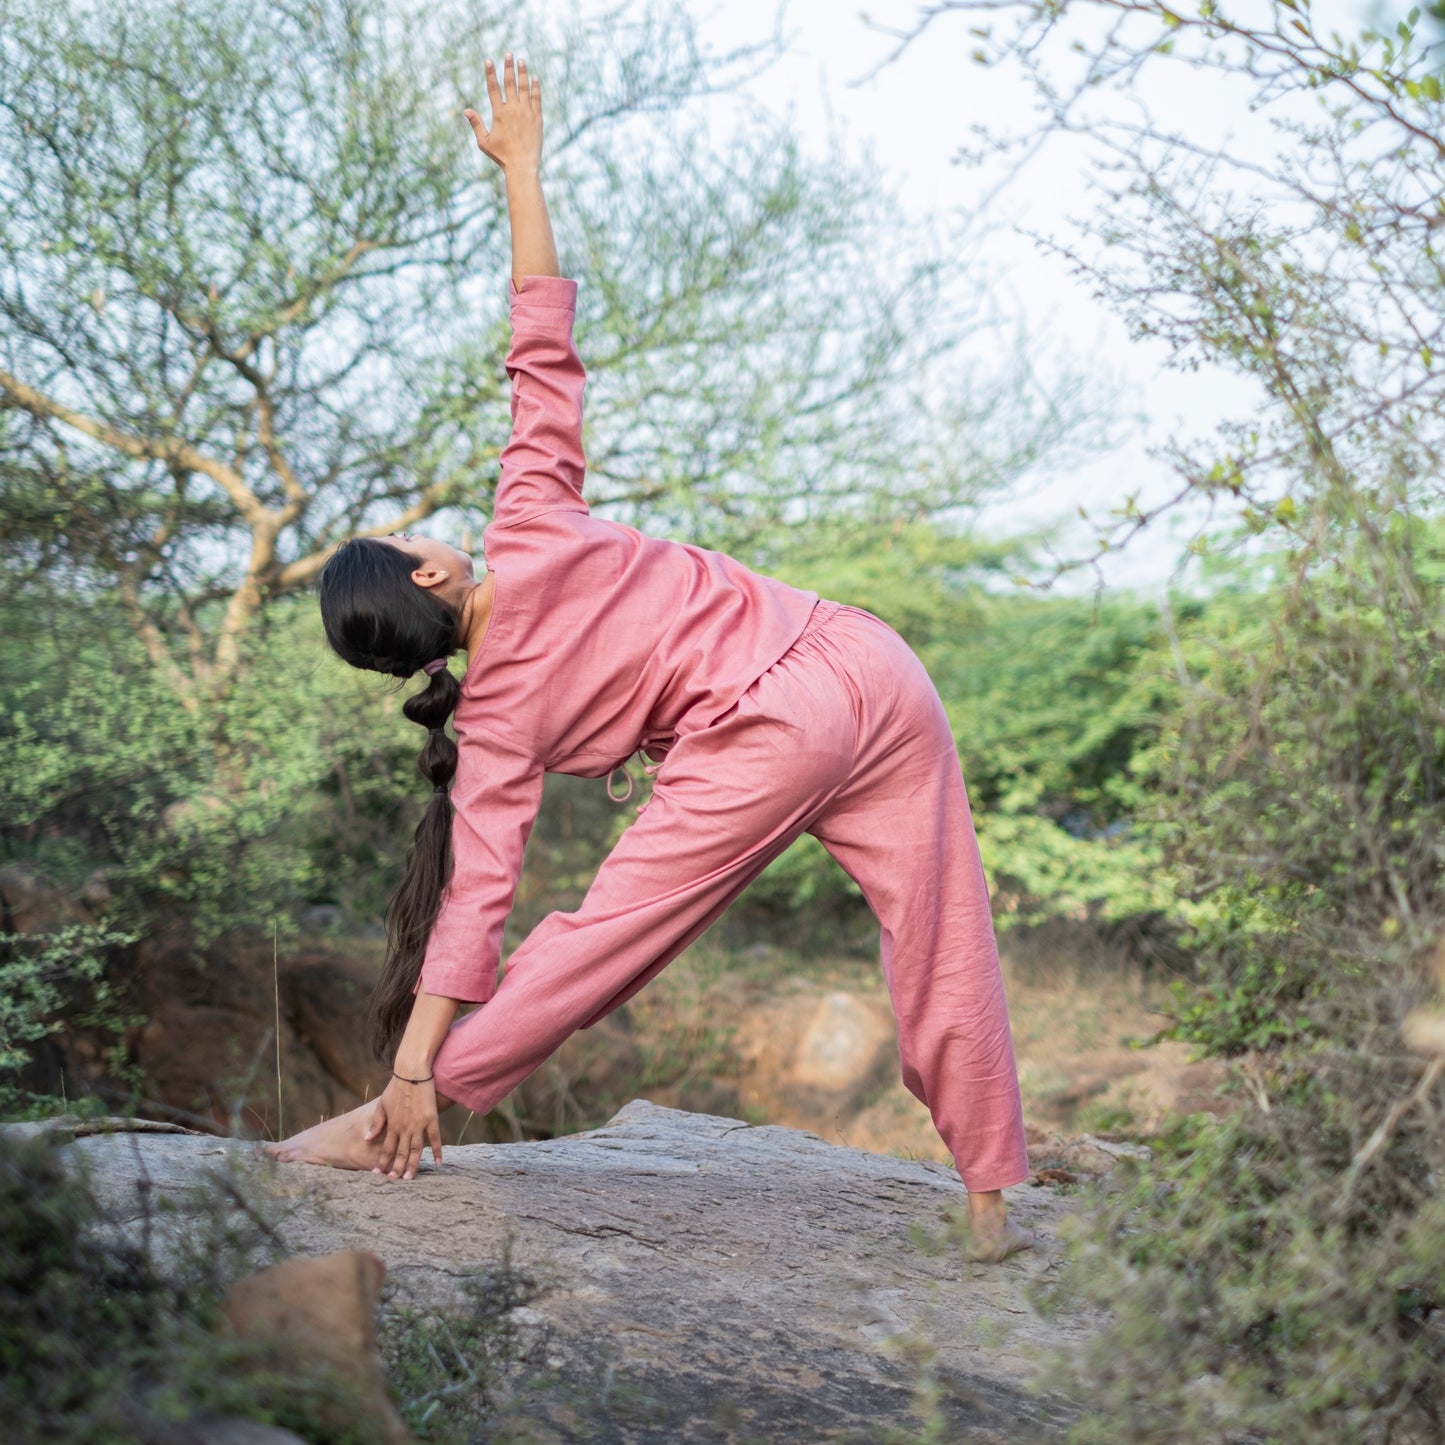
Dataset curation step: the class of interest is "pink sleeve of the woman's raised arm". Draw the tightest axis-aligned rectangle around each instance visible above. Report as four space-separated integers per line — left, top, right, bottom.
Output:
491 276 587 527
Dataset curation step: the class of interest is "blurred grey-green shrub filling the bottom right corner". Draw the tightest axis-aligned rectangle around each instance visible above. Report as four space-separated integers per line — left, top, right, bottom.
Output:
1049 1092 1445 1445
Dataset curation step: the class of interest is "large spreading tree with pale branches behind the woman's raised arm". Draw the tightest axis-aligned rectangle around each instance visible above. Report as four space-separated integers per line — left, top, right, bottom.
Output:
0 0 1063 715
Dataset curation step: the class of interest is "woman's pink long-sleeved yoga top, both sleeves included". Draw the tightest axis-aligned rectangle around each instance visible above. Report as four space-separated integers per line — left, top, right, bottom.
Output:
422 277 818 1003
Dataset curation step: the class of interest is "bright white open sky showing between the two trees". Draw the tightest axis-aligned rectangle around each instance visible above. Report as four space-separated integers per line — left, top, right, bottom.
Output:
569 0 1369 587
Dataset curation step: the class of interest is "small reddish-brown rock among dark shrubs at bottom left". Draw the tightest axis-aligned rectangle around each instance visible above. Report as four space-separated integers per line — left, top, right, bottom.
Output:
221 1250 410 1445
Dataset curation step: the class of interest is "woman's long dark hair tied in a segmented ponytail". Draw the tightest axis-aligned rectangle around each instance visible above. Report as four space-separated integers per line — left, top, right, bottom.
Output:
319 539 461 1062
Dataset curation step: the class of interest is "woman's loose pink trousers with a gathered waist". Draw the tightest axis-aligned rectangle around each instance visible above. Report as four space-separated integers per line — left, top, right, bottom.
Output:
435 603 1029 1191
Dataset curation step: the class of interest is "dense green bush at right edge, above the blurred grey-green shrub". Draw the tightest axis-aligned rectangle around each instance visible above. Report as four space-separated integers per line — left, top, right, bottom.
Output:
1163 522 1445 1055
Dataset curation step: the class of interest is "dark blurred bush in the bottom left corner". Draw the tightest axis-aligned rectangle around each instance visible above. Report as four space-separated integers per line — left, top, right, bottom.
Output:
0 1133 371 1445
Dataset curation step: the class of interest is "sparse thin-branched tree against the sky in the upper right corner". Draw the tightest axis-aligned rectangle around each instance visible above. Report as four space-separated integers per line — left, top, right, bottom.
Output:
900 0 1445 566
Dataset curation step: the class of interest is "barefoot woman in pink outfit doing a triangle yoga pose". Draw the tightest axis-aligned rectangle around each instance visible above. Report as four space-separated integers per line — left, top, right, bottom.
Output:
275 56 1030 1259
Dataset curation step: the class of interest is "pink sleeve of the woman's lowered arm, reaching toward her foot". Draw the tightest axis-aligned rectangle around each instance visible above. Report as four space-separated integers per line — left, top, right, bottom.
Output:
422 728 543 1003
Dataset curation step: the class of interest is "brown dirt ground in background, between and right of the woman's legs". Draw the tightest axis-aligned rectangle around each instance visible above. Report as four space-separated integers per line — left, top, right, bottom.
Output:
634 946 1222 1162
